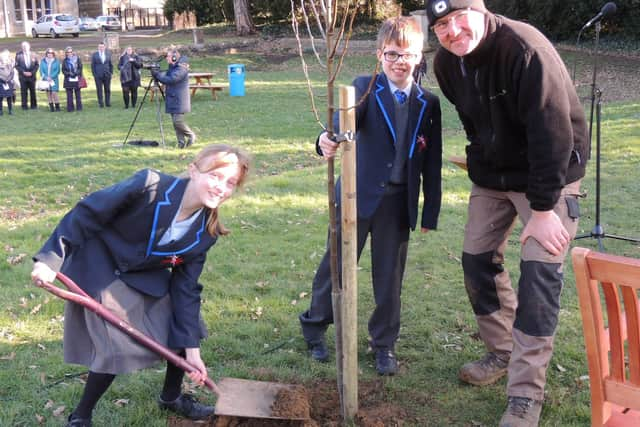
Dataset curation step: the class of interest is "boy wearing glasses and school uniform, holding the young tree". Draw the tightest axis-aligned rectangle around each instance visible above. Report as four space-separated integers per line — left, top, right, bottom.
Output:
299 17 442 375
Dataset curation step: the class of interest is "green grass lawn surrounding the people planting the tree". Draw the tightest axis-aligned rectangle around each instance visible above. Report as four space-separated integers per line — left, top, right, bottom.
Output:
0 41 640 427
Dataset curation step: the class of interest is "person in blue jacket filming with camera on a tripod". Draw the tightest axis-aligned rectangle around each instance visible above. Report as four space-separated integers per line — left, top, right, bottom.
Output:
151 49 196 148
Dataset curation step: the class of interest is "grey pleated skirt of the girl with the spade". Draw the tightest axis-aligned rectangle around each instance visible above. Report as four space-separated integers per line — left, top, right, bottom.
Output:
63 280 207 375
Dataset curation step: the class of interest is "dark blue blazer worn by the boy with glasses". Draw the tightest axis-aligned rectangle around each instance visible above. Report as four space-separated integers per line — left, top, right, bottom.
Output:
316 74 442 230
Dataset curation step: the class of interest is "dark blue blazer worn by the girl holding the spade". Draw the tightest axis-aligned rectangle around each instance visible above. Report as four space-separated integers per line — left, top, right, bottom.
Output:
34 169 216 348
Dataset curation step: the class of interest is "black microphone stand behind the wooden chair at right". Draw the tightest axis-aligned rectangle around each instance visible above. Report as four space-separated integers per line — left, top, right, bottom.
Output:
574 21 640 252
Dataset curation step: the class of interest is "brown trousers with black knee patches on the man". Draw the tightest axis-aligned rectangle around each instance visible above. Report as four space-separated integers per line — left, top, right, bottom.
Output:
462 181 580 400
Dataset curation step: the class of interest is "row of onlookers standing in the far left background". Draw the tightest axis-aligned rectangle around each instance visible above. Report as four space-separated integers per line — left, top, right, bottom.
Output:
0 41 142 115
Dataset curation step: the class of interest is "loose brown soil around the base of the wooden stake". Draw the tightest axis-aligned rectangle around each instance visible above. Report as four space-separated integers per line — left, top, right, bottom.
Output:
167 380 411 427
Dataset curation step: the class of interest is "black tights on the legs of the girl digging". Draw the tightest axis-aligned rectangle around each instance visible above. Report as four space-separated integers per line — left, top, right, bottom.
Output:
73 352 184 418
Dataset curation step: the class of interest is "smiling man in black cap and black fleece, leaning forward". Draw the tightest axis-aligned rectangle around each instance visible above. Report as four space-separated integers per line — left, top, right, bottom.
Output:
426 0 589 427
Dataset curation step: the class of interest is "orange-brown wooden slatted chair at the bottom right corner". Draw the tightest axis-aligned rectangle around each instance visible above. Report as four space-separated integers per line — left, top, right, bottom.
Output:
571 248 640 427
